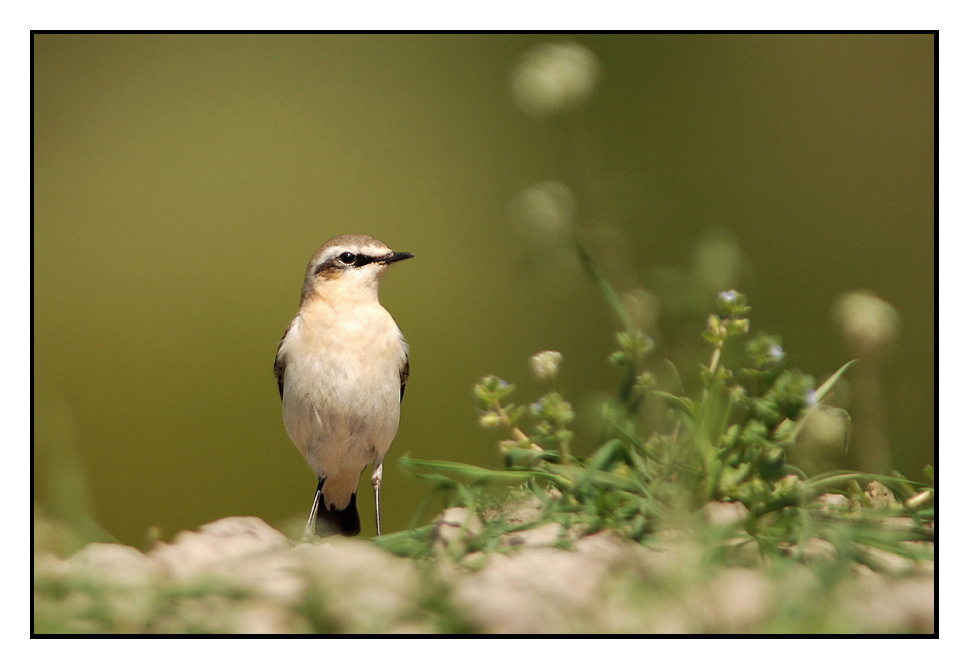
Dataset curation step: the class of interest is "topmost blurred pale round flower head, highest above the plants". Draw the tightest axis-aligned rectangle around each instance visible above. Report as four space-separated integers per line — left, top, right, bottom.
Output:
511 42 599 118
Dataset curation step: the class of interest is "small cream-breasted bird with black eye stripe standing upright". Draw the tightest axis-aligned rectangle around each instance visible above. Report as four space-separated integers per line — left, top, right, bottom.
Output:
275 235 413 539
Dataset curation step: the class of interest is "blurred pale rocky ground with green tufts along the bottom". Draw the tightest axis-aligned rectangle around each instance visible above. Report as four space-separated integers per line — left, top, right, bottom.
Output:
33 509 935 634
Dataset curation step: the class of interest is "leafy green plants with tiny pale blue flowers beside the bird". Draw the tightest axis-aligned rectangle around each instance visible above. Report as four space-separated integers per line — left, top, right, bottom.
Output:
379 249 935 567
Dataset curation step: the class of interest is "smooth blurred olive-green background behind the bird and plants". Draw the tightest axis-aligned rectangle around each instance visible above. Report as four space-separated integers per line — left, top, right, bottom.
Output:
33 35 936 546
